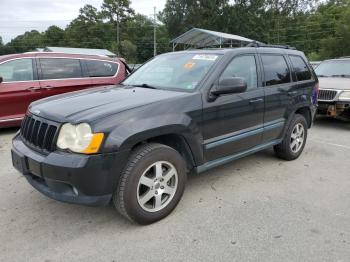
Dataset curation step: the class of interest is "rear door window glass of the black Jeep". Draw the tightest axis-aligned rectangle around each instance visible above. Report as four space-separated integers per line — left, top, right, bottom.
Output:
261 55 290 86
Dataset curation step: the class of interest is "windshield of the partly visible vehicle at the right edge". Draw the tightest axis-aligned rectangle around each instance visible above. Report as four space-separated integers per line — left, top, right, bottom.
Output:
315 60 350 77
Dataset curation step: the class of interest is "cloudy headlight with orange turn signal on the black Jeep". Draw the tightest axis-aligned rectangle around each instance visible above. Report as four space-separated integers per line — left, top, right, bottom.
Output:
57 123 104 154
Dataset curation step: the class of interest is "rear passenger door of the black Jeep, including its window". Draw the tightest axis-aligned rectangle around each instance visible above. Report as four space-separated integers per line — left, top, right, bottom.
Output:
261 53 298 143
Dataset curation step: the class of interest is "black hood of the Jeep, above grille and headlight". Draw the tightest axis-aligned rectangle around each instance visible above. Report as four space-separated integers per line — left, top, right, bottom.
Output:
29 86 188 123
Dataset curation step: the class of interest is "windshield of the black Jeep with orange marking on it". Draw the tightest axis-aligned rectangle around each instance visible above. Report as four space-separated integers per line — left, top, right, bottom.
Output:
122 53 220 90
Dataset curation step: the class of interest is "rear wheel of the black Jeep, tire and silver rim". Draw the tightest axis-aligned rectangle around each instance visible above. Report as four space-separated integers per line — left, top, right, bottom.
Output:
274 114 307 161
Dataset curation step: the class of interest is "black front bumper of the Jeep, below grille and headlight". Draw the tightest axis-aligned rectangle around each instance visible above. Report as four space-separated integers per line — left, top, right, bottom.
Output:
11 135 128 206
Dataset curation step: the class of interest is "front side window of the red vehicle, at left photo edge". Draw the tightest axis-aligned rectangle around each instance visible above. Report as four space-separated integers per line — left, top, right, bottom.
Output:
0 58 34 82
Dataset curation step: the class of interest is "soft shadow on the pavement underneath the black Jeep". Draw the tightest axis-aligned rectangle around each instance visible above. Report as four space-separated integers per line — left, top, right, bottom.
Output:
14 149 278 229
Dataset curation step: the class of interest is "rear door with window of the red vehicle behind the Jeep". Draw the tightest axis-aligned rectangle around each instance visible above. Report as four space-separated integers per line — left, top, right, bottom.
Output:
37 57 92 96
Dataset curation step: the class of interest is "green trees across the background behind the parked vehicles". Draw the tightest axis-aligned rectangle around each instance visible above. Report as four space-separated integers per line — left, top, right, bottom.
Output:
0 0 350 63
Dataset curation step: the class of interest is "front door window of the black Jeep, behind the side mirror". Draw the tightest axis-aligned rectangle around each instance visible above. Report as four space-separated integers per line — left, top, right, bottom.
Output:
220 55 258 89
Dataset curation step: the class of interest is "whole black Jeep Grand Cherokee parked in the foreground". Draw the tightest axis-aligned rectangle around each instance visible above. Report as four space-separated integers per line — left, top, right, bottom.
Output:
12 47 318 224
